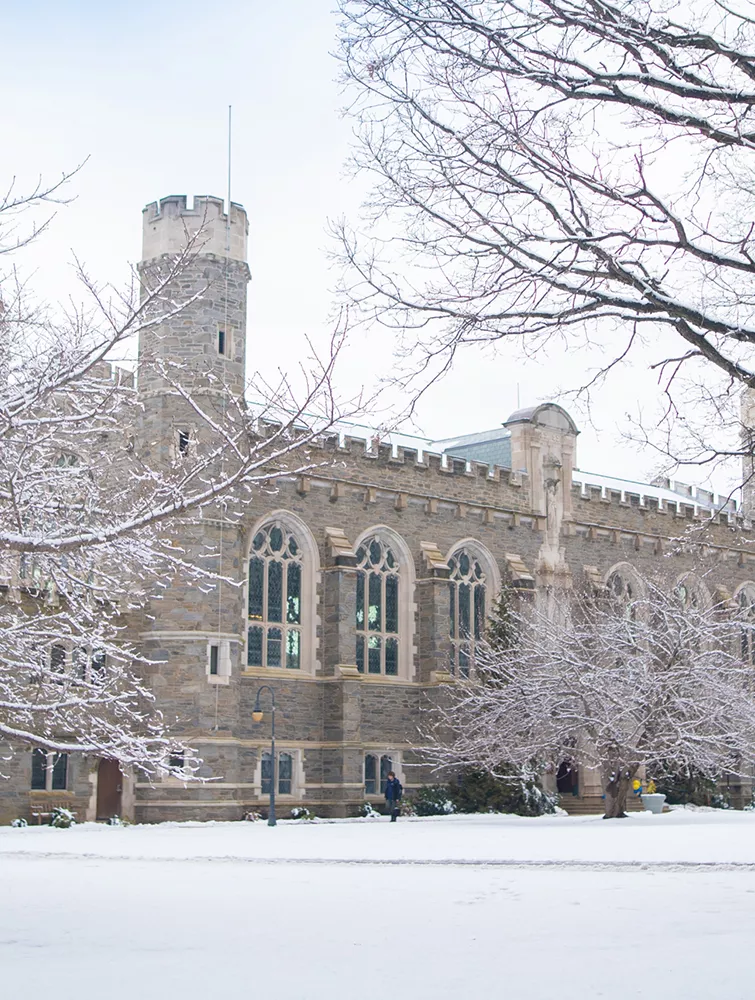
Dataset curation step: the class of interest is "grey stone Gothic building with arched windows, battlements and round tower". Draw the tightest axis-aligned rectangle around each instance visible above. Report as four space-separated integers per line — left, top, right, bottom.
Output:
5 197 755 822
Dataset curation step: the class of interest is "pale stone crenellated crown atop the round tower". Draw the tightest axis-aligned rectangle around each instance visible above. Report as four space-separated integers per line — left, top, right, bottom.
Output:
142 194 249 262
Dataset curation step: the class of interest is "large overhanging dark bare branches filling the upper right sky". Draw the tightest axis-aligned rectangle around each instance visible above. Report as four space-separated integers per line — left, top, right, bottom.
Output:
339 0 755 472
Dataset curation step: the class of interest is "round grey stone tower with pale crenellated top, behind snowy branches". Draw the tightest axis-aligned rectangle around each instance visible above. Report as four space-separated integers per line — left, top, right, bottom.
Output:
137 195 249 792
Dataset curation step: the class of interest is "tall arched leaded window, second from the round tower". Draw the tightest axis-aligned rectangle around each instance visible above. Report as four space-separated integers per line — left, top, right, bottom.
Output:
356 537 399 677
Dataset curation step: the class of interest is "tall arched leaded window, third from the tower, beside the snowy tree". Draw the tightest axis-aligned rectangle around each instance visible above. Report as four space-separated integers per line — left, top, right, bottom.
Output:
448 549 486 677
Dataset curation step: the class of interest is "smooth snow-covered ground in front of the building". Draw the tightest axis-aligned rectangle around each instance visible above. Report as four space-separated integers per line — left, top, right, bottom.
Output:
0 811 755 1000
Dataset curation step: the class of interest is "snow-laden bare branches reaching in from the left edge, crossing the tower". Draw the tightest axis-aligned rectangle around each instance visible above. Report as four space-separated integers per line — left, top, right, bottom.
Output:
0 180 353 776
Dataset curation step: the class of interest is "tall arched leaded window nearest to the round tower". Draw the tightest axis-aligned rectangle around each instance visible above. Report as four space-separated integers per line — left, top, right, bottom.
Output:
247 522 302 670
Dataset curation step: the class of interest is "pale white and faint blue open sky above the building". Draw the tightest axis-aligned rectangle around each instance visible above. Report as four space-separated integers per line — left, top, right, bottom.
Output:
0 0 723 486
